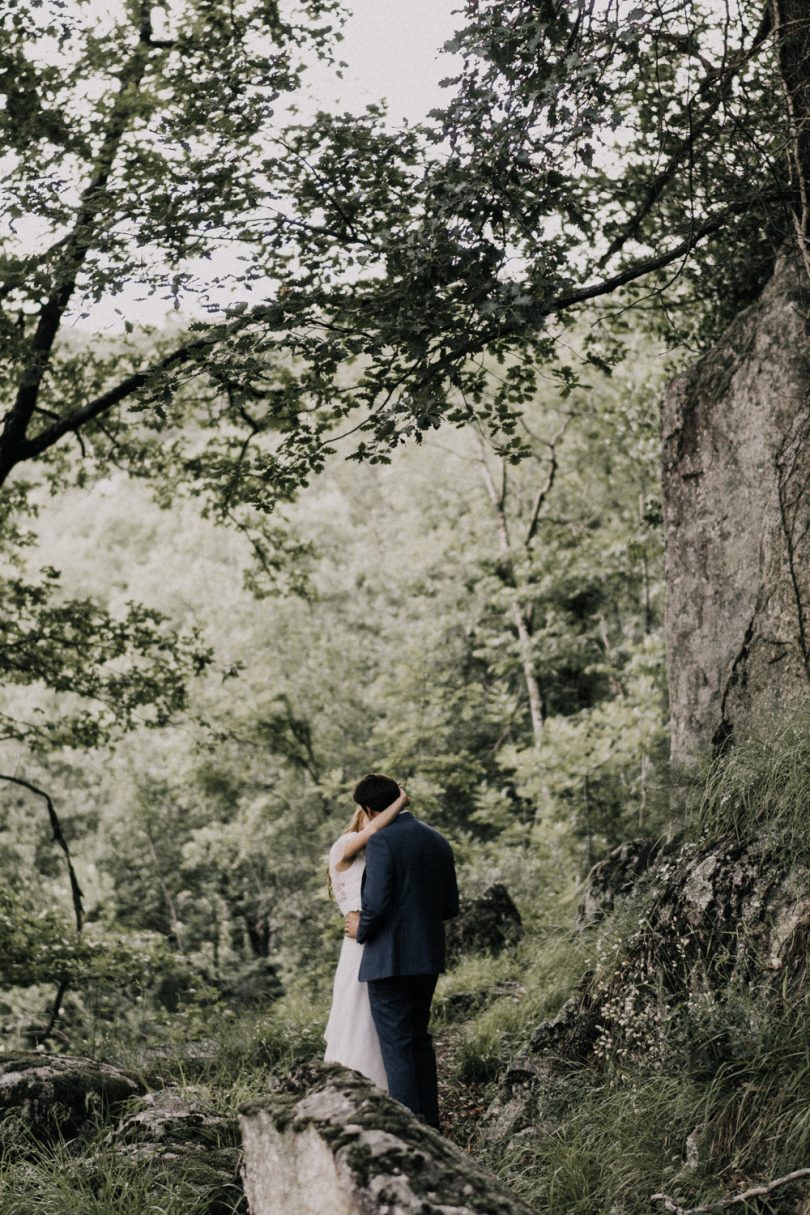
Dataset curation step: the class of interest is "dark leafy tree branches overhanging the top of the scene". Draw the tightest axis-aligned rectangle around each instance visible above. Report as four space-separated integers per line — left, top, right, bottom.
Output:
0 0 808 758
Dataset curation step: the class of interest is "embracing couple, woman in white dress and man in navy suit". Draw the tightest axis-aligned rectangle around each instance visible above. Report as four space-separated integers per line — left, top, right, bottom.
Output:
324 773 458 1128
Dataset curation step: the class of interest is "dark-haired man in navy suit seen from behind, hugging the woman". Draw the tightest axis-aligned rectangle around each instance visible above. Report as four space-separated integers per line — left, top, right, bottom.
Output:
346 773 458 1129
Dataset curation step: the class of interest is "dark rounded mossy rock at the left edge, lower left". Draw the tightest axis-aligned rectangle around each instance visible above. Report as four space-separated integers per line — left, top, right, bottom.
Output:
0 1052 143 1138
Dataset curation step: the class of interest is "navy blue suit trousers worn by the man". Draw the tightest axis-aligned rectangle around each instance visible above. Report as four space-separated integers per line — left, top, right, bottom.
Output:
368 974 438 1130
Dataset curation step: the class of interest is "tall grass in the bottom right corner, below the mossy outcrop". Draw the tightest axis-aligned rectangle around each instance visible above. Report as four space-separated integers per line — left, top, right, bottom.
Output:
481 981 810 1215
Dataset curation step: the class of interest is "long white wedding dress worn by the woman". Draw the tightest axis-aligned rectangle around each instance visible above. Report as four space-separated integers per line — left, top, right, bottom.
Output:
324 832 389 1092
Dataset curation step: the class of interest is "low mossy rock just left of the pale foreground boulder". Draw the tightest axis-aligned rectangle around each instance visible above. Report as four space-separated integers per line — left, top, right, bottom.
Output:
106 1089 244 1215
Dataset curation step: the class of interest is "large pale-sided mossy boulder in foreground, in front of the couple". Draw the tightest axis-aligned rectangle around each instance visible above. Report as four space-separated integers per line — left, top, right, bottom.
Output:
240 1067 532 1215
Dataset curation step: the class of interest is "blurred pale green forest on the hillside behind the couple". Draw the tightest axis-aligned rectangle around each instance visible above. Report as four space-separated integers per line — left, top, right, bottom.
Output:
2 337 665 1041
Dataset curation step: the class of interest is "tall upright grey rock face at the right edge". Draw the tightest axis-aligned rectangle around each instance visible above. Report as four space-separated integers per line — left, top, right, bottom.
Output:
662 243 810 763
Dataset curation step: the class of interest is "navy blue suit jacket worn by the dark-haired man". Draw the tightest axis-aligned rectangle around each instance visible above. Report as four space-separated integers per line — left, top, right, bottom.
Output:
357 810 459 982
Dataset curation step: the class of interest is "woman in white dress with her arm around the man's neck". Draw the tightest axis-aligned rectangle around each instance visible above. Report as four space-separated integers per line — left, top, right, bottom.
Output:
323 789 409 1092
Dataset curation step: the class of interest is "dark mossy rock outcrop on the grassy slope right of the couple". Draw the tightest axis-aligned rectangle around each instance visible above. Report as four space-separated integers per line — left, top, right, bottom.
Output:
483 838 810 1142
